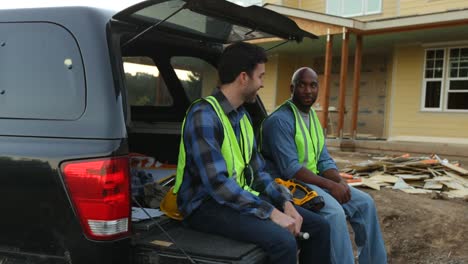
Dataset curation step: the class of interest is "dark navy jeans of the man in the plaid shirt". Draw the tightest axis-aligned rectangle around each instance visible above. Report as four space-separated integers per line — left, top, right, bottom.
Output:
184 199 331 264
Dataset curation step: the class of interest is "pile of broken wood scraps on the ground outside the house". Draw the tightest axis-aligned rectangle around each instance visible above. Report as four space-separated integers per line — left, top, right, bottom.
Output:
340 154 468 200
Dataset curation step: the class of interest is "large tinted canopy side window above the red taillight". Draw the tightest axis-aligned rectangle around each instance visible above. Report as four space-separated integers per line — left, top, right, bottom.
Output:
0 22 86 120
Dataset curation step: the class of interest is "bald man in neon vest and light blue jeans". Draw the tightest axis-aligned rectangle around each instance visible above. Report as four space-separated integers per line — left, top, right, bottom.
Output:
261 67 387 264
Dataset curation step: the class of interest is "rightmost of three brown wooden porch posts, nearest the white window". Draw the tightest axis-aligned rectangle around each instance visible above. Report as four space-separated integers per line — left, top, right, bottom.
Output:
351 35 362 139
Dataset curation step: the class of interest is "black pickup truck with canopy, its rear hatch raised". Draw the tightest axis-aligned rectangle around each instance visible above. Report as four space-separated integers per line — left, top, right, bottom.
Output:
0 0 314 264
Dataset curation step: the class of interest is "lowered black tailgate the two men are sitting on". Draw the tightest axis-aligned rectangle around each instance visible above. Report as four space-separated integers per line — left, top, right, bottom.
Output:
134 218 266 264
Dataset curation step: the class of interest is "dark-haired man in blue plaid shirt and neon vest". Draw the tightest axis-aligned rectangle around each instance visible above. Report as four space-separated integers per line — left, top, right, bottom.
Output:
174 43 330 264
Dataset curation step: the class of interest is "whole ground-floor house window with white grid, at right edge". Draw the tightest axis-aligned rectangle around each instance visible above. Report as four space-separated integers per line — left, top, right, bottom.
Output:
422 47 468 111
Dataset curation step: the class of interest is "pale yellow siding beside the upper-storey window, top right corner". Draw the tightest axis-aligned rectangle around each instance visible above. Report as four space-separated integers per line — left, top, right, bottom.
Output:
400 0 468 16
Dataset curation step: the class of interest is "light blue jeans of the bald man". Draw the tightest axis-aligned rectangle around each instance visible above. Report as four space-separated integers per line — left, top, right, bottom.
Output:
309 184 387 264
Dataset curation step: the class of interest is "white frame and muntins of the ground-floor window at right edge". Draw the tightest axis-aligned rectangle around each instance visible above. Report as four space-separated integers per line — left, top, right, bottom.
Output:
420 46 468 113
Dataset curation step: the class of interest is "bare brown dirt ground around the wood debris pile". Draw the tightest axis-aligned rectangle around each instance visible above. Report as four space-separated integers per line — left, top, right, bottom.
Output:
331 151 468 264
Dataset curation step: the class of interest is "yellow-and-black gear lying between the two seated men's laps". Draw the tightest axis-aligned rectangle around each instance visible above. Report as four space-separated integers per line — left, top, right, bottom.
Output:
275 178 325 212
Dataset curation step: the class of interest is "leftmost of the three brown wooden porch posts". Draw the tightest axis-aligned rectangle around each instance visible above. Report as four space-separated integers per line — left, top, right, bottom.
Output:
322 29 333 136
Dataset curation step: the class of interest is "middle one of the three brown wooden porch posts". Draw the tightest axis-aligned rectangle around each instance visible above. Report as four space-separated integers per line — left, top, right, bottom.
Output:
337 27 349 139
